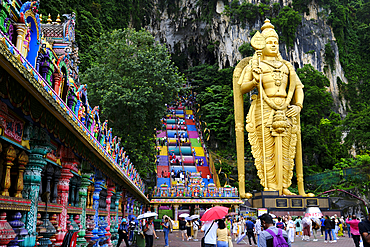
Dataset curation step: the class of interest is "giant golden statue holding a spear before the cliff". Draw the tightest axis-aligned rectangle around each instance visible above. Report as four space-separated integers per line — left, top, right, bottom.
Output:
233 20 313 198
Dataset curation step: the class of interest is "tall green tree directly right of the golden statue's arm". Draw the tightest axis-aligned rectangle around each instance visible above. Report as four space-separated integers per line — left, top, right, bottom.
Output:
297 65 347 174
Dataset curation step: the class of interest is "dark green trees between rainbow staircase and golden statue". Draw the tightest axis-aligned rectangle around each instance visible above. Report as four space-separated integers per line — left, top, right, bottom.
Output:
185 64 251 158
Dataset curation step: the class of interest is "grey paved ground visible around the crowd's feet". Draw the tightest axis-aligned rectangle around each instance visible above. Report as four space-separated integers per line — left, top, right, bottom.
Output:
154 231 362 247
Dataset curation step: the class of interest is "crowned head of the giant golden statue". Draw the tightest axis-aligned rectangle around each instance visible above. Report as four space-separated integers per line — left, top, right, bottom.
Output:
261 19 279 56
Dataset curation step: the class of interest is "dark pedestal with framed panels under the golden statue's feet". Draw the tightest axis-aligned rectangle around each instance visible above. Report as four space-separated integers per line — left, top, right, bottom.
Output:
251 191 331 216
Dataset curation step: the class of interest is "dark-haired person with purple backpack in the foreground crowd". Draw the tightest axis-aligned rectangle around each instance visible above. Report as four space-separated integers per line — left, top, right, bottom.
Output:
259 214 292 247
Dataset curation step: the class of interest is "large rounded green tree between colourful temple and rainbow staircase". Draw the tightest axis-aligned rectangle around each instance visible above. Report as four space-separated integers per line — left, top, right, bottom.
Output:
81 29 184 176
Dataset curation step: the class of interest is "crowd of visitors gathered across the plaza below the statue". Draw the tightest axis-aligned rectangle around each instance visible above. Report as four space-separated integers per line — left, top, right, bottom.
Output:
117 214 370 247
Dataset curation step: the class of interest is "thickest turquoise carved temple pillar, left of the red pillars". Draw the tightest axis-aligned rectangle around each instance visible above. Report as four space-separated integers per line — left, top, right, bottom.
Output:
20 125 52 247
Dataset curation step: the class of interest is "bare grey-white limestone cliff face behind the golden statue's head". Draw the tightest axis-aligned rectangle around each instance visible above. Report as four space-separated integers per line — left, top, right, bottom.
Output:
146 0 347 116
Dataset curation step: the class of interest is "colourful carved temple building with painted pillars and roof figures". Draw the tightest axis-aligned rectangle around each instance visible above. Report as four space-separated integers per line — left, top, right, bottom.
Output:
0 0 149 247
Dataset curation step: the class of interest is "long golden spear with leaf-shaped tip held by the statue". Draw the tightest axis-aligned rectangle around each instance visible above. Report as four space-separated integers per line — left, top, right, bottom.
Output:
251 31 268 189
